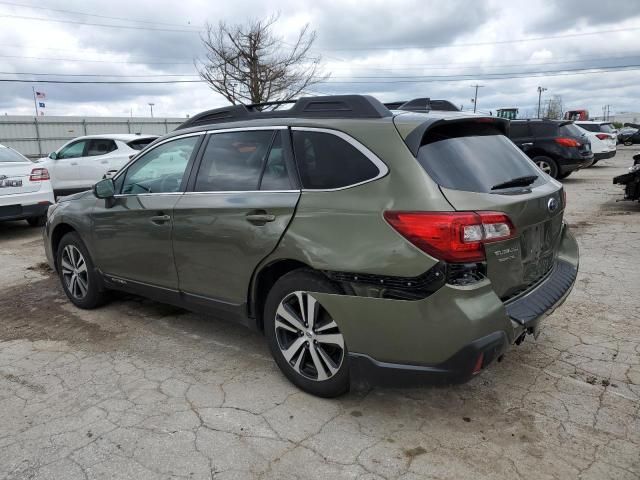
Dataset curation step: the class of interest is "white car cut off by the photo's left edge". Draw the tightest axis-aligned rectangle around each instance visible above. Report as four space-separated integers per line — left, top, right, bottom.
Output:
0 145 54 227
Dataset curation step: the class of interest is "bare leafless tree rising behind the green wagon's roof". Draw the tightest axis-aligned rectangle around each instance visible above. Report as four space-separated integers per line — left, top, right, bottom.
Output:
195 15 329 105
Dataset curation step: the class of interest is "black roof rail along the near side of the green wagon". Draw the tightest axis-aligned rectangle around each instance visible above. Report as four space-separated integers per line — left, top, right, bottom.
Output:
176 95 392 130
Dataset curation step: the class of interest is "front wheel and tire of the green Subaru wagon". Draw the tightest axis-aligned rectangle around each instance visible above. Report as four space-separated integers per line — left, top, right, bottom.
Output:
56 232 107 310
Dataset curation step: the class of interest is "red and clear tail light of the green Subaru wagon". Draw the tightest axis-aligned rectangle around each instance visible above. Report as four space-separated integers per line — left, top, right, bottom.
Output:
384 211 515 263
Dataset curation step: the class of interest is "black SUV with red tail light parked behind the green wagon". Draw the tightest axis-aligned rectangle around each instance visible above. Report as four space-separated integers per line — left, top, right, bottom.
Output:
509 119 594 179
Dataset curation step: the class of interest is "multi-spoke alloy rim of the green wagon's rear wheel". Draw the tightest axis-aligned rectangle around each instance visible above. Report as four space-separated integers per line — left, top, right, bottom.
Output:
274 292 345 381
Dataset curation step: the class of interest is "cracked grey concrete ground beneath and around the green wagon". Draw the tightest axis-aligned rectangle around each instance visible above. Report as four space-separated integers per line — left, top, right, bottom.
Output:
0 148 640 480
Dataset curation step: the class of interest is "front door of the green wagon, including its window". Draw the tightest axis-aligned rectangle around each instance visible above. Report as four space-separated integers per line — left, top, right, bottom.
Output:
92 135 202 289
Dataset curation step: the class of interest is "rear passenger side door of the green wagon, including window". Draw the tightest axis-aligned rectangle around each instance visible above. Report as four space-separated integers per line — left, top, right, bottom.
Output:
173 128 300 307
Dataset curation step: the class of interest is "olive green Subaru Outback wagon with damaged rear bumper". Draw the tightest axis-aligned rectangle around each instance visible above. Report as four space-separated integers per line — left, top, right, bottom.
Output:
44 95 578 397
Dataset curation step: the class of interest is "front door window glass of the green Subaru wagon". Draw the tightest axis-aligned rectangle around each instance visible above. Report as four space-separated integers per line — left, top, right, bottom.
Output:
122 136 200 195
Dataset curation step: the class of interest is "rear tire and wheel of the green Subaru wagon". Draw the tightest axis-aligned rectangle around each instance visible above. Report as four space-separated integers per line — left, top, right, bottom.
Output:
264 270 349 398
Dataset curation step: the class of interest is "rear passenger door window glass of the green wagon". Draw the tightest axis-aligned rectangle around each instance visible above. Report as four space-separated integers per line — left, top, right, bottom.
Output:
195 130 274 192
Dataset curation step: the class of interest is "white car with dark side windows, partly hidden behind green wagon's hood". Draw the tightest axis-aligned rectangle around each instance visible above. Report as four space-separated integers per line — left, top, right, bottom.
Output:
39 134 158 195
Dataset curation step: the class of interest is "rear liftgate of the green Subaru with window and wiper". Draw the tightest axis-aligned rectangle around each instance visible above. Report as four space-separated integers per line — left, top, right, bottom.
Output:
418 122 564 298
